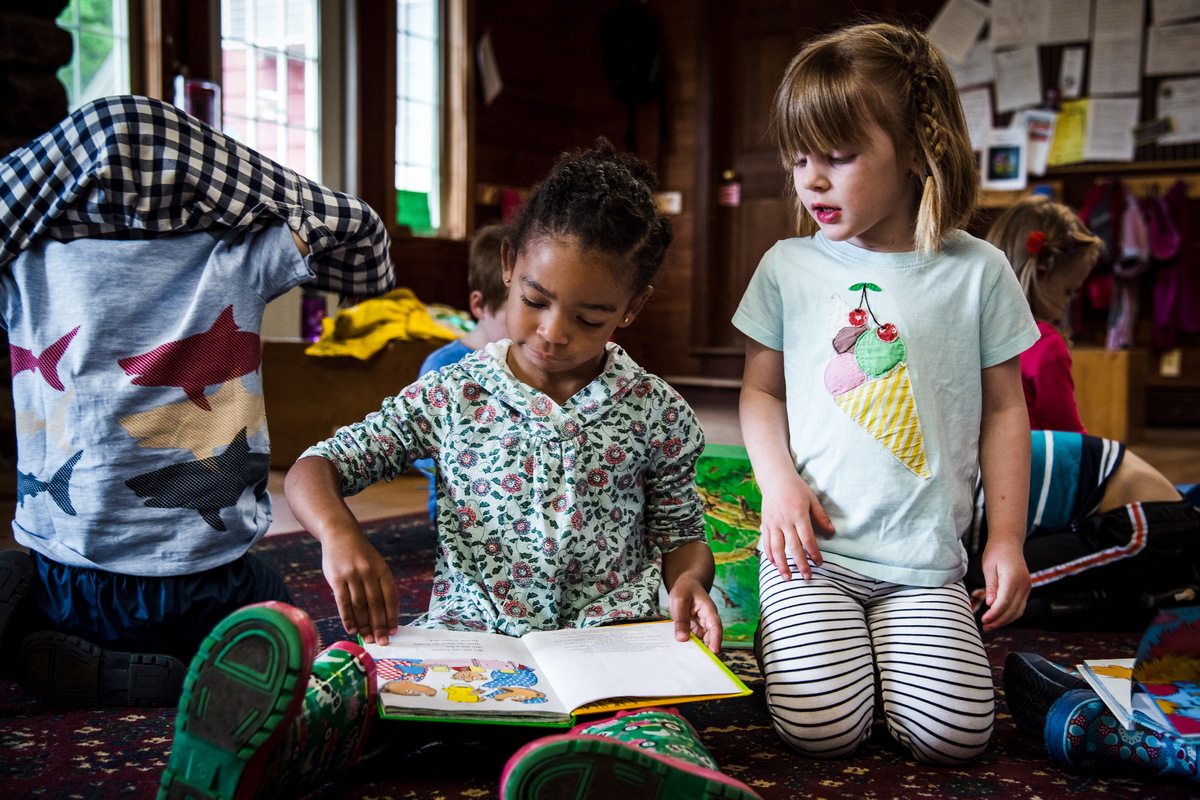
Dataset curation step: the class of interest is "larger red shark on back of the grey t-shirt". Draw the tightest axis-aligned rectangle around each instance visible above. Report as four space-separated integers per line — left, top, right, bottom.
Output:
118 306 262 411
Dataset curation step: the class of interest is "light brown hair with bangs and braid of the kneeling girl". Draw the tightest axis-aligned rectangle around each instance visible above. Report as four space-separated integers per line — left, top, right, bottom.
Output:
772 23 979 252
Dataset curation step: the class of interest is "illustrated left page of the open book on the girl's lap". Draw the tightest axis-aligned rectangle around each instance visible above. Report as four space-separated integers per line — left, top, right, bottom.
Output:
362 627 574 717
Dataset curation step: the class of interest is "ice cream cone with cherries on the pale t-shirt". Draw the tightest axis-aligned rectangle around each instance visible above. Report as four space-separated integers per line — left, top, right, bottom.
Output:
824 283 930 479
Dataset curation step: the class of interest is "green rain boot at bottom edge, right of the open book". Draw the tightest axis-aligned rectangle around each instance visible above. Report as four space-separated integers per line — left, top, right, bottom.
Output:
500 708 758 800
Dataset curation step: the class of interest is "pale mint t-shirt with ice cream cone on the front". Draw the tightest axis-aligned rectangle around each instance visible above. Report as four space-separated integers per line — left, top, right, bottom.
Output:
733 231 1038 587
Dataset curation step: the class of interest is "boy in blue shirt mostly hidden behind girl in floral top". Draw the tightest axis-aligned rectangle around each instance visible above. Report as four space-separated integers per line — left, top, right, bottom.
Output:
414 224 509 522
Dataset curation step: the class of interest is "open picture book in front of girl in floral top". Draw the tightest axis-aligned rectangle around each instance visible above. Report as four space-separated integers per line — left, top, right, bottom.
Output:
364 620 750 726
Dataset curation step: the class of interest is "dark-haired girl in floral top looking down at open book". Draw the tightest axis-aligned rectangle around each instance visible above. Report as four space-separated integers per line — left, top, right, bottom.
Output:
279 140 756 798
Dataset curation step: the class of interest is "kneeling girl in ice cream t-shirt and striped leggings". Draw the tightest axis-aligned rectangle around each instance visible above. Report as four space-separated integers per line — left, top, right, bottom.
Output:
733 24 1038 764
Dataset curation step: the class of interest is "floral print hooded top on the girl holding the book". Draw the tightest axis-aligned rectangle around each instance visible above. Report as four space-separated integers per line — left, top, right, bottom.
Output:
301 339 704 636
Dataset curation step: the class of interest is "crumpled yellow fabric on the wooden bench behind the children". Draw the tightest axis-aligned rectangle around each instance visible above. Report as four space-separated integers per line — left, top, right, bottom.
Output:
305 289 458 361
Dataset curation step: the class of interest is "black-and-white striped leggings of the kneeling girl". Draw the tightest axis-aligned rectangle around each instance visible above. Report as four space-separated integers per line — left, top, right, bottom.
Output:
758 559 994 765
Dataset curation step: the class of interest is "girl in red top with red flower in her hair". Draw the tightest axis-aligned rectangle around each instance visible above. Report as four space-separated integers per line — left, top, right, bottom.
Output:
988 196 1104 433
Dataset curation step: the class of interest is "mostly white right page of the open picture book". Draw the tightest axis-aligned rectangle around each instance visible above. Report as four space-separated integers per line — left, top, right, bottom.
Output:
522 620 743 709
